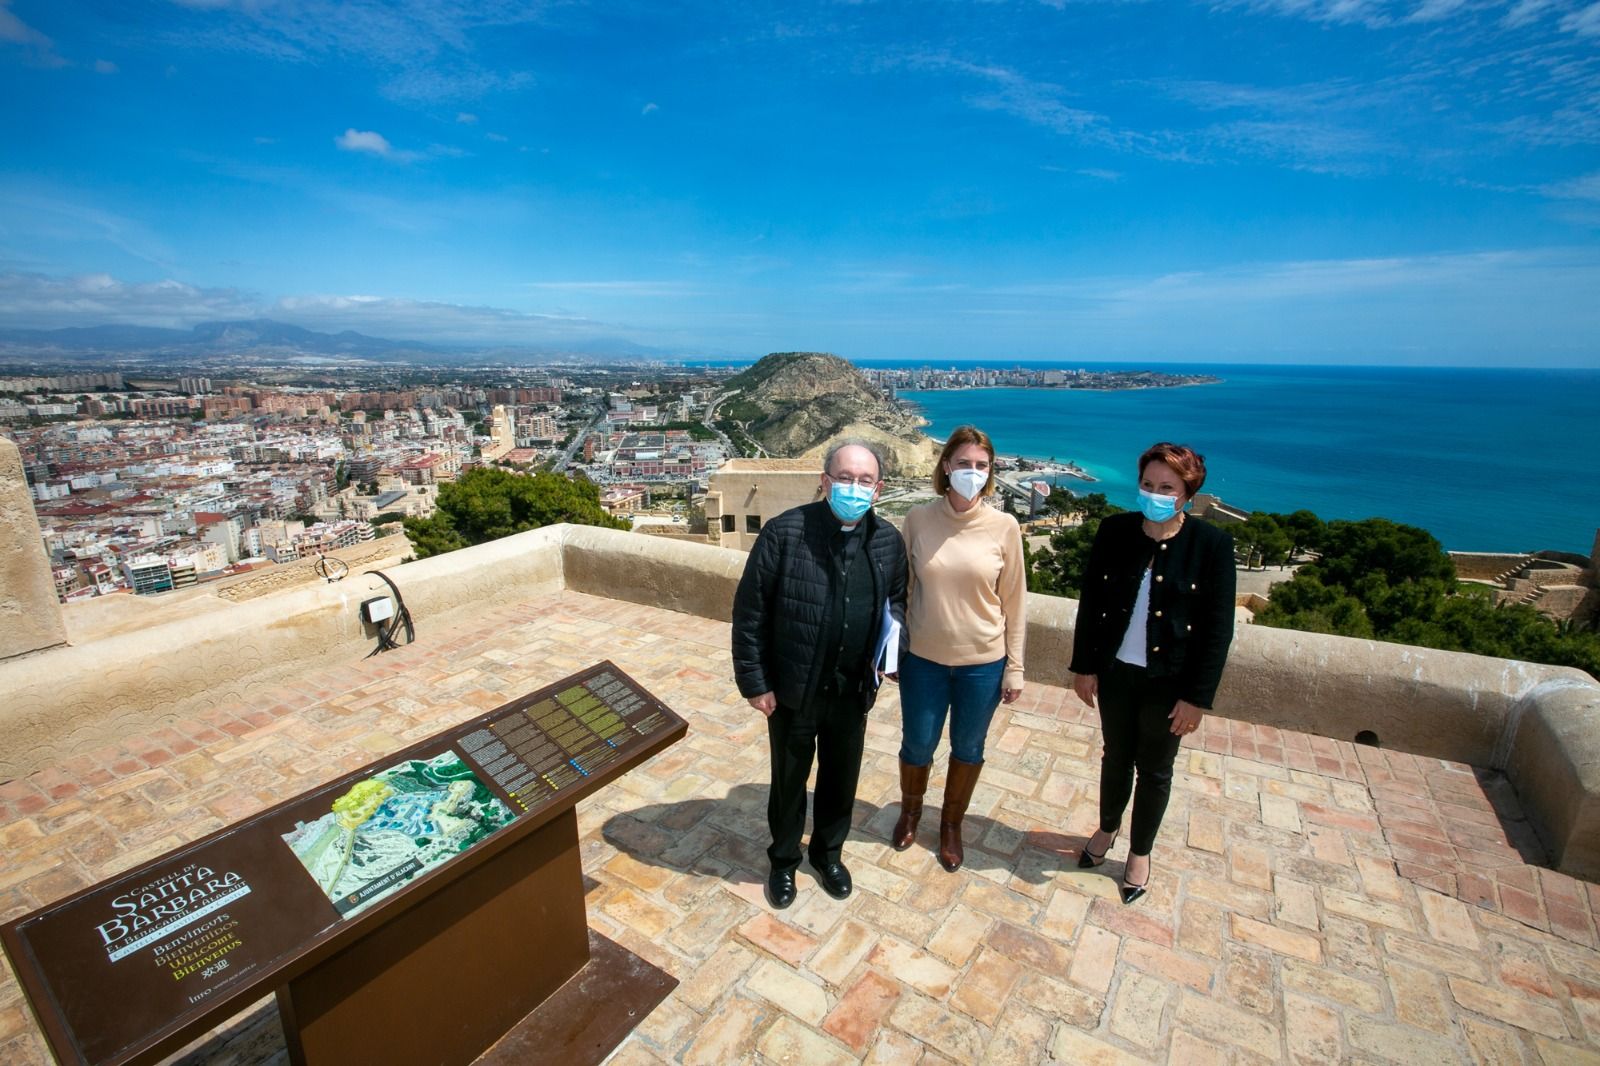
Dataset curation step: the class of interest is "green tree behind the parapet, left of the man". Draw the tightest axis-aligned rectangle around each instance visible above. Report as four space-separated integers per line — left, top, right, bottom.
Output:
405 467 627 559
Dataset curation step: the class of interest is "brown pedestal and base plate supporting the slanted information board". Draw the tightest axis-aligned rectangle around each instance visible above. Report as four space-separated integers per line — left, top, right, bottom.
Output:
278 807 677 1066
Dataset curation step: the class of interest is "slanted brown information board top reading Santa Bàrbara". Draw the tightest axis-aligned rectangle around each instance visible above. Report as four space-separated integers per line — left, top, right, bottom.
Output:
0 663 685 1063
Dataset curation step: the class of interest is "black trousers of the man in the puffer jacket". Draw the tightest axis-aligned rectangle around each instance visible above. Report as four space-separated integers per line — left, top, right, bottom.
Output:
766 696 867 871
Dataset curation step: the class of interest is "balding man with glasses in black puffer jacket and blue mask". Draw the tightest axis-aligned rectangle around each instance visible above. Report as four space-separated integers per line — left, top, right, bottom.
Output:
733 440 906 909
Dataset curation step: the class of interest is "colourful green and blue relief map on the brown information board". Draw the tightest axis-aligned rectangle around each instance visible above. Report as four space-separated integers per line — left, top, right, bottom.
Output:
283 751 515 917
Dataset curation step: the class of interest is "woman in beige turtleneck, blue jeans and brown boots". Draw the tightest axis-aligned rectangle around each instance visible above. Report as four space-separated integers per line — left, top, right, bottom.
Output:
893 426 1027 871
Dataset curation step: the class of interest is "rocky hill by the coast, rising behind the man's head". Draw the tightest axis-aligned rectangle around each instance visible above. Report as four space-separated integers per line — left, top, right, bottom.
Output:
722 352 939 477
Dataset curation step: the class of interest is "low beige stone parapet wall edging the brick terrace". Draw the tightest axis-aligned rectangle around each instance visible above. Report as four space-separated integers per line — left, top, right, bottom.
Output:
0 527 1600 877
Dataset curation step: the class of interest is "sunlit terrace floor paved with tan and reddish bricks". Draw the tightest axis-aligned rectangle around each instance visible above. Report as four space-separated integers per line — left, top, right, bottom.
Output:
0 591 1600 1066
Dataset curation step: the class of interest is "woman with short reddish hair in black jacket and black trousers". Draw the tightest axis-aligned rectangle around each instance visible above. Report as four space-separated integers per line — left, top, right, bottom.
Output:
1072 442 1234 903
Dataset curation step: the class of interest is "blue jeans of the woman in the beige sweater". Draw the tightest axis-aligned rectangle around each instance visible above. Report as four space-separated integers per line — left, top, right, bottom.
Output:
901 651 1005 767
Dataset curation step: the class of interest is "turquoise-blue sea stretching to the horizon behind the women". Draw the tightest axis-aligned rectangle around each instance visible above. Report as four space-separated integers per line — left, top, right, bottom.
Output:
902 362 1600 555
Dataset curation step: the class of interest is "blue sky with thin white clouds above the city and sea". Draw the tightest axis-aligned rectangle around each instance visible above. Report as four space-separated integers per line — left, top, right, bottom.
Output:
0 0 1600 367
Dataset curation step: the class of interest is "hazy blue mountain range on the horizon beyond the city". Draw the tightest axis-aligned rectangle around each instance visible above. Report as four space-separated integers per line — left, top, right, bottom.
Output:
0 319 674 363
